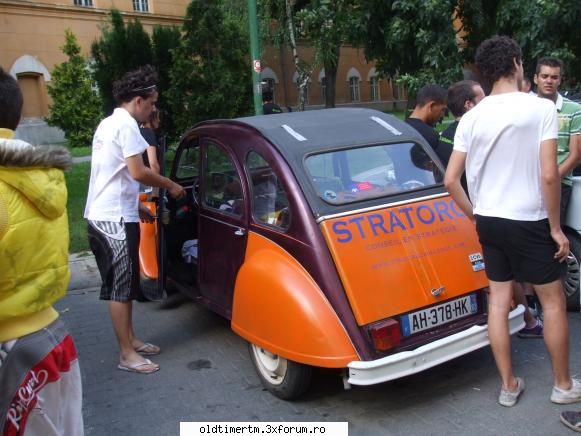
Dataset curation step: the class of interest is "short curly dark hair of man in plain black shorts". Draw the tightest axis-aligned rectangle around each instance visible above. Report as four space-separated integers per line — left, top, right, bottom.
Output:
475 36 522 85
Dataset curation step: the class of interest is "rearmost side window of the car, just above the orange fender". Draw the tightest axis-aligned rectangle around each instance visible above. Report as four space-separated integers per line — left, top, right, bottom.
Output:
246 151 290 230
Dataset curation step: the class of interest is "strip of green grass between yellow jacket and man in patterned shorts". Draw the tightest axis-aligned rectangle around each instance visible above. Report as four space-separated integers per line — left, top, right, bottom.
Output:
65 162 91 253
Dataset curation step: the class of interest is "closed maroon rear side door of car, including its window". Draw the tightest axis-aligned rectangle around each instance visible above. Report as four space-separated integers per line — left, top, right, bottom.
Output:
198 138 248 319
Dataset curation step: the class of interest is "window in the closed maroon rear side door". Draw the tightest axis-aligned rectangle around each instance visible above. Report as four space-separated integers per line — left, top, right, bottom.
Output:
203 143 243 216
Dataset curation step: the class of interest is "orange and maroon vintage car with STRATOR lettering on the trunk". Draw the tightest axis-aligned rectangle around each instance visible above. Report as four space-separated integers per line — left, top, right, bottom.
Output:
138 109 524 399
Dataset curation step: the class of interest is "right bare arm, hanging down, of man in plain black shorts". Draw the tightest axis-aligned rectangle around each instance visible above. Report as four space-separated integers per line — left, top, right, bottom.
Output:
540 139 569 262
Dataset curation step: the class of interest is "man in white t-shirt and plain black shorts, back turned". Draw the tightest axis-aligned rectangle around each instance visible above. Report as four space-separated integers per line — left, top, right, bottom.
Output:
445 36 581 406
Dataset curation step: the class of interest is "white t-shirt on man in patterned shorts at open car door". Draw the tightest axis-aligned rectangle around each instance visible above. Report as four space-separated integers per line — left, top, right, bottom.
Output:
84 108 148 222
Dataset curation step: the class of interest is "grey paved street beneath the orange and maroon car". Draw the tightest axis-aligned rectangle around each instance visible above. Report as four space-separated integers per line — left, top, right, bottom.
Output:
62 257 581 436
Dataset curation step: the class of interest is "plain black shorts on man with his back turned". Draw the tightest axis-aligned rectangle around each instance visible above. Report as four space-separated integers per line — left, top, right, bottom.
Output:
476 215 566 285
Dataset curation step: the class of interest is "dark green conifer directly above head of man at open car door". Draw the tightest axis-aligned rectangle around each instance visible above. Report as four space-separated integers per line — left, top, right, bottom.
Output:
91 9 153 113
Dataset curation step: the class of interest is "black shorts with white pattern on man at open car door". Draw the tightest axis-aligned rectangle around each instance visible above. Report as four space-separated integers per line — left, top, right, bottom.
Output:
88 221 143 301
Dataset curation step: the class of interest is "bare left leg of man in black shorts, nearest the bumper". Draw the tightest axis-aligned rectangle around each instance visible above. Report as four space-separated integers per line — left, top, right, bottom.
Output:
488 280 517 391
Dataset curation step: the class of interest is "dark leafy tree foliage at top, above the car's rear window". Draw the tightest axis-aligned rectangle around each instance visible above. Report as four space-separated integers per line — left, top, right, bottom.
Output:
358 0 462 95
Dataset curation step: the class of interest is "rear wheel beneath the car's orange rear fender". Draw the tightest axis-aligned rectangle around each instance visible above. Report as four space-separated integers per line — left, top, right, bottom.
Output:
248 343 312 400
